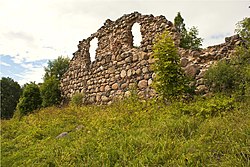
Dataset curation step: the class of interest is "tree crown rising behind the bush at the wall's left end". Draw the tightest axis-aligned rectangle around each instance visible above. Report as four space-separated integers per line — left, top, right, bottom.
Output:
44 56 70 80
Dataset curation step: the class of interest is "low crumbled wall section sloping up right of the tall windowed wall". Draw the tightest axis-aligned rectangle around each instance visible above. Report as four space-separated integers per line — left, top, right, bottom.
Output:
179 35 242 93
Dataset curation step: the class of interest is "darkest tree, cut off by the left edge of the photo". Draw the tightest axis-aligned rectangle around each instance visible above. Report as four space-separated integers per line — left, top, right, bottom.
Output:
0 77 22 119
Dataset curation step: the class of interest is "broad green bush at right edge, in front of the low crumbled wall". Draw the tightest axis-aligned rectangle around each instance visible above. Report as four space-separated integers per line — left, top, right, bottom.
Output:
204 47 250 99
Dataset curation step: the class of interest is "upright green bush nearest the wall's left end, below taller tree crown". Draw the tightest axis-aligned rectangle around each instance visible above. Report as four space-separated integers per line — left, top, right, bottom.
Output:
40 76 61 107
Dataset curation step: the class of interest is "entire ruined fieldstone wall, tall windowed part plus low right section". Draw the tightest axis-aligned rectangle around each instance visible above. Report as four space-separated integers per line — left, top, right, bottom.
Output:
61 12 242 104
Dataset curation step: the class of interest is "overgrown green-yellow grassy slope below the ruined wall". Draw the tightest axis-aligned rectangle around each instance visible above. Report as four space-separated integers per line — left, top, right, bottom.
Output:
1 96 250 167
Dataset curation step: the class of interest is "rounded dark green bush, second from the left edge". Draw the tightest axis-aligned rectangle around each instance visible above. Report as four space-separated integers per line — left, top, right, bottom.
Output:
16 82 42 116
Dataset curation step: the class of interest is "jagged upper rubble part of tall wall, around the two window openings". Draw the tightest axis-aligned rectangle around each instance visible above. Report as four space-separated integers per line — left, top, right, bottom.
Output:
69 12 178 68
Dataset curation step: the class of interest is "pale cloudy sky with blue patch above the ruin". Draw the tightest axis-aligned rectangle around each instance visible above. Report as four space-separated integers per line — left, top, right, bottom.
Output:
0 0 250 85
